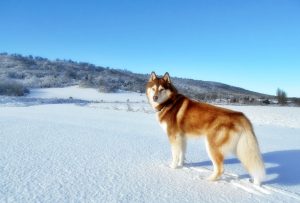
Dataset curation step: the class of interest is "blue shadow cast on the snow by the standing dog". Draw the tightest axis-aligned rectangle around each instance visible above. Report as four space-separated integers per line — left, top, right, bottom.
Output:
187 150 300 185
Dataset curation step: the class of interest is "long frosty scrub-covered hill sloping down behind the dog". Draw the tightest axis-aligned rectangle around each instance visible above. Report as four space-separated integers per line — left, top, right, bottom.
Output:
0 53 271 100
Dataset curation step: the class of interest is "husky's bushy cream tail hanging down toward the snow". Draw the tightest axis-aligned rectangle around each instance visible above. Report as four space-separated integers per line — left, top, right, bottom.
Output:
237 118 265 185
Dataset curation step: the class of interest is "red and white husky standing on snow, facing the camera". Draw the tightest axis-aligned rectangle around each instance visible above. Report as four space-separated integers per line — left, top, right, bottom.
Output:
146 72 265 185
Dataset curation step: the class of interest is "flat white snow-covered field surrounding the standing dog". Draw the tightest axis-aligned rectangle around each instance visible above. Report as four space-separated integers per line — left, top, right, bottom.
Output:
0 86 300 203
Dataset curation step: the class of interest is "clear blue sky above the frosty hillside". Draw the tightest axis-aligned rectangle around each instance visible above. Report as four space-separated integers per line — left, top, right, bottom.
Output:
0 0 300 97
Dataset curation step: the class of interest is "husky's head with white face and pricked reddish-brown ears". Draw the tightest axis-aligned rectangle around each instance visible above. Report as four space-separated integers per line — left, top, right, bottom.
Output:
146 72 177 108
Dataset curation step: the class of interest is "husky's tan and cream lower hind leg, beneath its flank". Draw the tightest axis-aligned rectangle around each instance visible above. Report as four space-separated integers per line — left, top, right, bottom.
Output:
205 138 224 181
